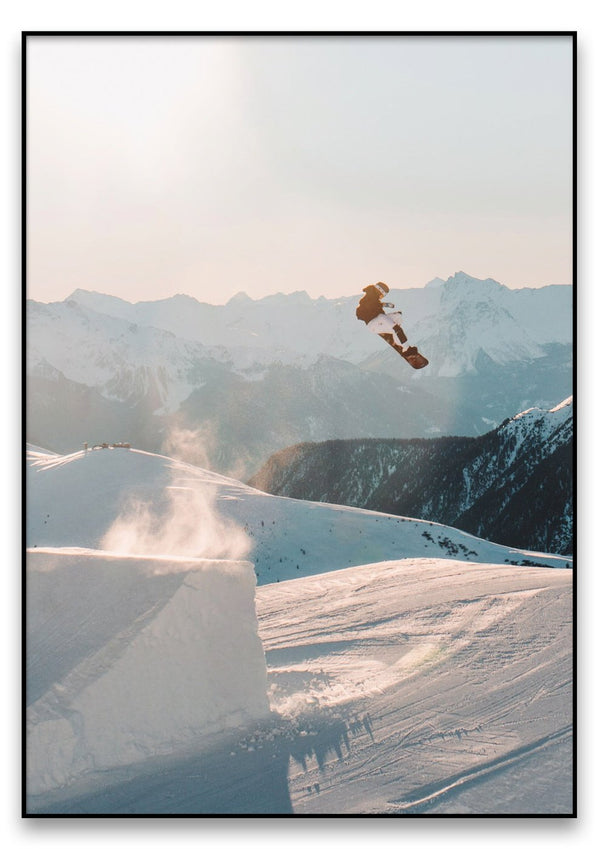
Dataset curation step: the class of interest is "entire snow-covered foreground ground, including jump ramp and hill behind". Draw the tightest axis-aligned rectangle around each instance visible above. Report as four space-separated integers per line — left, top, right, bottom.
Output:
26 449 572 815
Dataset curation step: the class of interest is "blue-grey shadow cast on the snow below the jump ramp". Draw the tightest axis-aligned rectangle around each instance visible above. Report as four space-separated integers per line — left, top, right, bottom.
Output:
27 712 374 816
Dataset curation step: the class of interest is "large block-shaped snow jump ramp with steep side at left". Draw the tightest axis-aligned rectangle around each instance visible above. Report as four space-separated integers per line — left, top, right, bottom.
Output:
26 549 269 795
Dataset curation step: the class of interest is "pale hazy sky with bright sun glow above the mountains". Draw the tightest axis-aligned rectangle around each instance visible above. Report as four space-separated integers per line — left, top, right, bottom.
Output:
26 36 573 303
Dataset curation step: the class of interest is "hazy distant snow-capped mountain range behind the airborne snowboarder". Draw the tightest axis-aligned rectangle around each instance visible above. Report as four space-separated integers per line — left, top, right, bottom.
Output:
27 273 572 477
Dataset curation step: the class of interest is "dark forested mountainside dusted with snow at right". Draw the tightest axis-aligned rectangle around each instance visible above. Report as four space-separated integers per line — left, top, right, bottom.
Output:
250 398 573 553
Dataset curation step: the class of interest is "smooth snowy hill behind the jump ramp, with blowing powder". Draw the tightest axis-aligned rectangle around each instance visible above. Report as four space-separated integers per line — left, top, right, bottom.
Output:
27 440 572 572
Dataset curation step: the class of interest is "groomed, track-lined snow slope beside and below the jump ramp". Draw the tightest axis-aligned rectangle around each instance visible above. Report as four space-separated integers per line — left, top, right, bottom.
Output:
31 559 573 815
